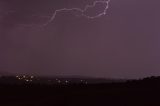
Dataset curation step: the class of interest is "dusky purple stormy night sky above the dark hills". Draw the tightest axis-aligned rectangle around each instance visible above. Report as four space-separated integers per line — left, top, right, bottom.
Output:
0 0 160 78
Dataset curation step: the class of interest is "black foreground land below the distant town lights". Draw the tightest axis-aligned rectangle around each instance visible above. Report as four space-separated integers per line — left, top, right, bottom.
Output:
0 78 160 106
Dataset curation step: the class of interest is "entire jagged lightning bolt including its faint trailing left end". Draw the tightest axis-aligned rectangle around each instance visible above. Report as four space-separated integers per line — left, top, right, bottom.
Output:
16 0 111 29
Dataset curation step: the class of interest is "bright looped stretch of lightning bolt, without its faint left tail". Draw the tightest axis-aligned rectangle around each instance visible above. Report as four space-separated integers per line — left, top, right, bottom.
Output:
43 0 110 26
